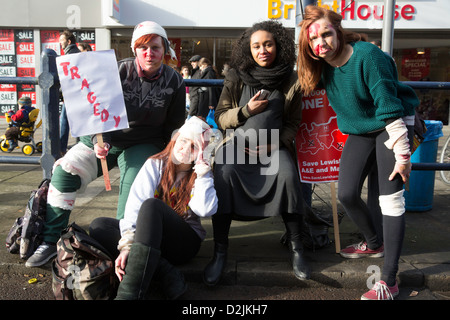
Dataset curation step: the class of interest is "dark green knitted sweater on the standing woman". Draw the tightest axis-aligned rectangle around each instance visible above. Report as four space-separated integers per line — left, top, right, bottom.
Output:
322 41 419 134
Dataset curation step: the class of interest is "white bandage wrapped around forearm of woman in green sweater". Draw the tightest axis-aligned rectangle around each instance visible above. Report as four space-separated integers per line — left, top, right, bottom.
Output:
384 118 411 164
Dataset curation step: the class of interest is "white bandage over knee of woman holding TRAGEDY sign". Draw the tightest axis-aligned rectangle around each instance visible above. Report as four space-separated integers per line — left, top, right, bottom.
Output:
54 143 98 193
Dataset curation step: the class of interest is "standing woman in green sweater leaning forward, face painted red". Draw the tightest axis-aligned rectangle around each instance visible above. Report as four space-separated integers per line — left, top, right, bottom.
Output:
298 6 419 300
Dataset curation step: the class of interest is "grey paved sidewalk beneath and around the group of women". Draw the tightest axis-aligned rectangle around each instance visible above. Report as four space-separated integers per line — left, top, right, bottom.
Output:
0 120 450 298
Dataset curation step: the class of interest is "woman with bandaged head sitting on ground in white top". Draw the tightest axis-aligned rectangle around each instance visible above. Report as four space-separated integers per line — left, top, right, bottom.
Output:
90 117 217 300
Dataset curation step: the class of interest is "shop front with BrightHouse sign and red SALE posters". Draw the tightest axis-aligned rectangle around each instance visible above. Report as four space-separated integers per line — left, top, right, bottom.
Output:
0 0 450 125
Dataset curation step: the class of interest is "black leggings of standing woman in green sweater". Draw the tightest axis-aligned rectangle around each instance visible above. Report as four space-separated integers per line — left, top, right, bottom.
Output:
338 127 412 285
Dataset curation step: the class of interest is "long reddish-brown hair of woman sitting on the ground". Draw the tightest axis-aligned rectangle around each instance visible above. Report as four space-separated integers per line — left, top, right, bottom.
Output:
150 133 197 217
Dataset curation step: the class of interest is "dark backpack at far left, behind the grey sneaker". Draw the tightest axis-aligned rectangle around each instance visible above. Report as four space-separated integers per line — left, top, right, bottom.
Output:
6 179 50 259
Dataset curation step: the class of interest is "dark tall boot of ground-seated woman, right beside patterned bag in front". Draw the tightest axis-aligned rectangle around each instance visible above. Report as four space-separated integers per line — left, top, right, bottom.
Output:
116 242 161 300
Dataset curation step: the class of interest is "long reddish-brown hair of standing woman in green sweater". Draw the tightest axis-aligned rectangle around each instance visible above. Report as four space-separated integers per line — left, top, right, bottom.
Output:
297 5 367 95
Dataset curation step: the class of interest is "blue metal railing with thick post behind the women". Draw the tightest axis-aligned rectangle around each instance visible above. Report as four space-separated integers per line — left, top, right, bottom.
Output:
0 49 450 178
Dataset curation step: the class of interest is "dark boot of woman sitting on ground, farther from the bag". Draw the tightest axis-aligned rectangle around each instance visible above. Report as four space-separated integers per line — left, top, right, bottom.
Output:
155 257 187 300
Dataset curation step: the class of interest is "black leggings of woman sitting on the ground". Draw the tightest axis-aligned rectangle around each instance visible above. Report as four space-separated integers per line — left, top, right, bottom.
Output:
89 198 201 264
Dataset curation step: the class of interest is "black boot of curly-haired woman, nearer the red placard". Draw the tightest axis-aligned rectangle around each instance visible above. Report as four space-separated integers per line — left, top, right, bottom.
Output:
281 213 311 280
